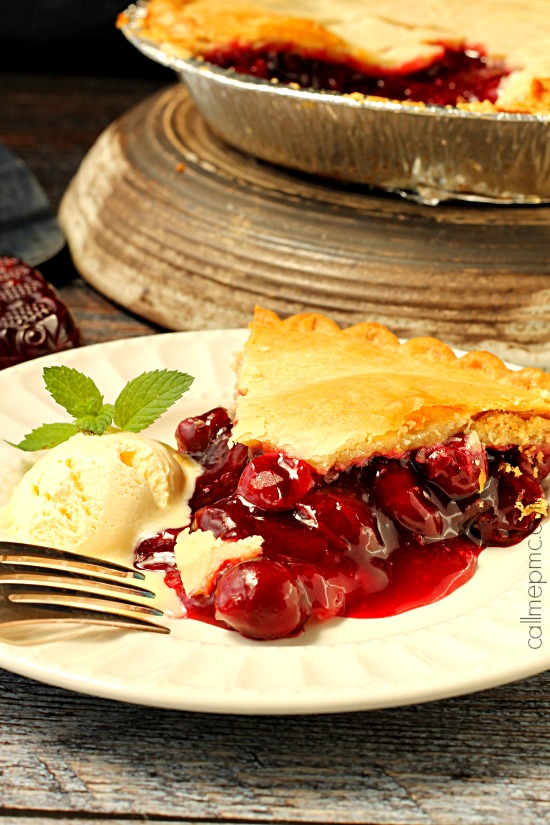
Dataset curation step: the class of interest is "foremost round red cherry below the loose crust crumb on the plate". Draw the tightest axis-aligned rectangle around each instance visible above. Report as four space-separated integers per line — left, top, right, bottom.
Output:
214 559 309 639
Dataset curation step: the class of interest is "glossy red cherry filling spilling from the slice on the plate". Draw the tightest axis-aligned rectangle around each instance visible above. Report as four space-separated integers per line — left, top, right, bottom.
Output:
135 408 550 639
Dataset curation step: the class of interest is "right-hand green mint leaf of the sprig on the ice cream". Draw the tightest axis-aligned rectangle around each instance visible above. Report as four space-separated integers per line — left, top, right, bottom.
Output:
114 370 194 433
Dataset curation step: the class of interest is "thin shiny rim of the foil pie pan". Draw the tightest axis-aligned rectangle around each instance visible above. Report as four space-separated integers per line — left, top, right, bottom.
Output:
120 0 550 125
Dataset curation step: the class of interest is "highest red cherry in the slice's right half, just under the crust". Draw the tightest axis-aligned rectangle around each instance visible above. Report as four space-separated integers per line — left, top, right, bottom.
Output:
414 434 488 499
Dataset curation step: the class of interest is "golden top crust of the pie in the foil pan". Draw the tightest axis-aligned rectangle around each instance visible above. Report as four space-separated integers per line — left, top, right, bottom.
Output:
128 0 550 113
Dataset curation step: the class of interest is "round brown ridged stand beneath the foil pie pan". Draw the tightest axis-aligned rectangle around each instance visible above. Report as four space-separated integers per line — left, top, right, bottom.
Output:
60 84 550 368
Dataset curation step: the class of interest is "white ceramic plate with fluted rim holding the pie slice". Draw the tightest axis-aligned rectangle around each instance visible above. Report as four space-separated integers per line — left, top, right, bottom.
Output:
0 330 550 714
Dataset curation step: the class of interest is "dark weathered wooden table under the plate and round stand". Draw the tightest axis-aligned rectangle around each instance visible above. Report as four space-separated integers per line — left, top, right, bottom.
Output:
0 76 550 825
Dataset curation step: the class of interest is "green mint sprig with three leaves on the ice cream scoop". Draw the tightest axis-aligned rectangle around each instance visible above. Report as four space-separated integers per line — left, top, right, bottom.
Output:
8 366 194 452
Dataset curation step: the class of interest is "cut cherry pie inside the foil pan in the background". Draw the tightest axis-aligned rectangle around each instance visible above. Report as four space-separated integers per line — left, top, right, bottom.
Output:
127 0 550 113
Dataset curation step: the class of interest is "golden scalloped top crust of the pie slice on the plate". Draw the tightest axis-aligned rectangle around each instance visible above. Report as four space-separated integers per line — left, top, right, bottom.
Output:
233 308 550 473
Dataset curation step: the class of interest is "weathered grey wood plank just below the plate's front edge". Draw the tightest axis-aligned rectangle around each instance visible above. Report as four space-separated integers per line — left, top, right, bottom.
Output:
0 672 550 825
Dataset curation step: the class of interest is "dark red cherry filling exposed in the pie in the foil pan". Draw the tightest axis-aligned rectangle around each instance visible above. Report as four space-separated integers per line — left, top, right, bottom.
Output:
205 44 510 106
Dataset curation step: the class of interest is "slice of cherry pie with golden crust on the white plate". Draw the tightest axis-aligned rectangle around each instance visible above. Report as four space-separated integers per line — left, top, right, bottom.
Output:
136 309 550 639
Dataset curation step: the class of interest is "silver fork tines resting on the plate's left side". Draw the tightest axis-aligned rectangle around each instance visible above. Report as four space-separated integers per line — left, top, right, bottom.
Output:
0 541 170 633
